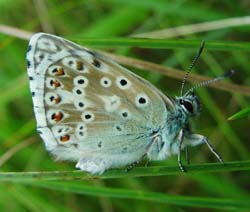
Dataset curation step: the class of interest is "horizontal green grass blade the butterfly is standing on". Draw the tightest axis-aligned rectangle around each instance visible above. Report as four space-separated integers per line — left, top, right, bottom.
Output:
0 161 250 182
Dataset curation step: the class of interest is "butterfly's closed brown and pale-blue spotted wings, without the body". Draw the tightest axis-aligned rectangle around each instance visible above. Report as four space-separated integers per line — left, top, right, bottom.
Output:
27 33 170 172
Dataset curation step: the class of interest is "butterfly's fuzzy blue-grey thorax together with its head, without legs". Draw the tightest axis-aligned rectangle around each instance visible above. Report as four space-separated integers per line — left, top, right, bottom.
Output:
149 93 200 160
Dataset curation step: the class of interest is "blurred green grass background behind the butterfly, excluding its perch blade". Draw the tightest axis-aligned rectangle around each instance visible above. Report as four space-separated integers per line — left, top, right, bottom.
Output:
0 0 250 212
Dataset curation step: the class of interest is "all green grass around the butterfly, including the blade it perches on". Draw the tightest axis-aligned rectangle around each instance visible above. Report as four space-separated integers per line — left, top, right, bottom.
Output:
0 0 250 212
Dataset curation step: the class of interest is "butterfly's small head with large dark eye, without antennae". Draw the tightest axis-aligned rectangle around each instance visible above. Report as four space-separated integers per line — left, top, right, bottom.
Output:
177 91 201 116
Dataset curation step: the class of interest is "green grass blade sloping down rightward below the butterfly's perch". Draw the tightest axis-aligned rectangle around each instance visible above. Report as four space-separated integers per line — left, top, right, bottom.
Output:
17 181 250 210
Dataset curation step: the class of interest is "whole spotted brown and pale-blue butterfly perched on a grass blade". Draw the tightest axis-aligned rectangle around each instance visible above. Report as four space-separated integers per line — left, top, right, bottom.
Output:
26 33 230 174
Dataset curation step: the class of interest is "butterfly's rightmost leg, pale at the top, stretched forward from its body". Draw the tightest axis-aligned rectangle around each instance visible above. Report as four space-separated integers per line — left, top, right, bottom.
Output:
185 134 224 163
